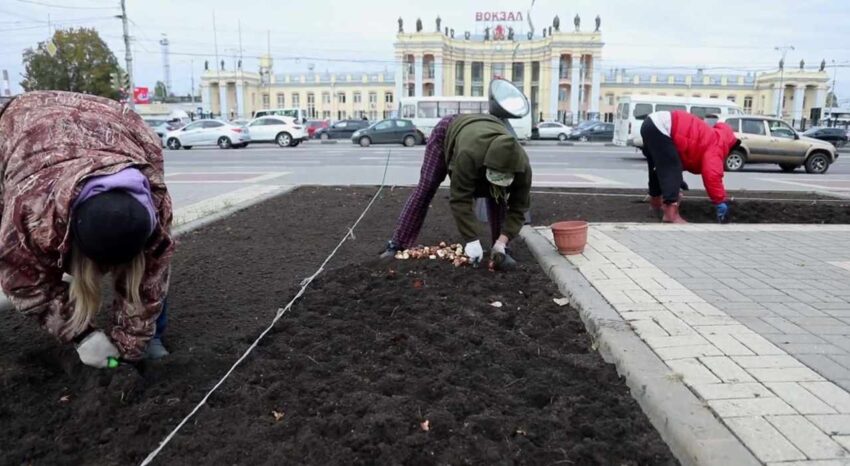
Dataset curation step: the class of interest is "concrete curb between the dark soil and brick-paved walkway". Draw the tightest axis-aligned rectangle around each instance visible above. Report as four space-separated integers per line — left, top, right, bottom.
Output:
520 226 762 466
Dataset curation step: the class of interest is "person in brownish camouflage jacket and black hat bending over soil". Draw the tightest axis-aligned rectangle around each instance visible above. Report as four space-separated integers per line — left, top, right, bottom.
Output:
0 91 174 367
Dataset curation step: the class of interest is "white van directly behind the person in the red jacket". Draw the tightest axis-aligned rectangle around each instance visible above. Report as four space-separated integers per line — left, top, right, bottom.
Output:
614 95 744 147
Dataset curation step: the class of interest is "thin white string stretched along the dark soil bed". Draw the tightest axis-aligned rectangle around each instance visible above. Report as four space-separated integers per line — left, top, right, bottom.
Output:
141 149 392 466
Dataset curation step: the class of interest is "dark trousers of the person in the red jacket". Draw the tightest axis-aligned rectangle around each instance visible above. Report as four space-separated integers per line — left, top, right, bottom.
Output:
640 117 682 204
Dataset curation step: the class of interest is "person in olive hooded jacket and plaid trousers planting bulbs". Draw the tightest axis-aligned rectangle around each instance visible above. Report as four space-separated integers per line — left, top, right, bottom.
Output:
383 114 531 268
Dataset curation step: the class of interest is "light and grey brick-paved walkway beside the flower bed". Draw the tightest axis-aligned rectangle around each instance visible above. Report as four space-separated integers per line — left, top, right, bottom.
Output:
539 224 850 466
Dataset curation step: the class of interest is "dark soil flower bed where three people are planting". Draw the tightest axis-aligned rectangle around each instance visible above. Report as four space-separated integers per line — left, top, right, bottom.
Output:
0 187 846 465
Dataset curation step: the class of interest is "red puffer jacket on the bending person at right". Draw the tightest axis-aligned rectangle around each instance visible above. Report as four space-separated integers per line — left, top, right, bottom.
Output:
670 110 738 204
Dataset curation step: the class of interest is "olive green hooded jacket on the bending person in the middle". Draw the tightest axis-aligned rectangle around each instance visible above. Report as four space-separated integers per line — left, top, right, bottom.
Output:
444 114 531 241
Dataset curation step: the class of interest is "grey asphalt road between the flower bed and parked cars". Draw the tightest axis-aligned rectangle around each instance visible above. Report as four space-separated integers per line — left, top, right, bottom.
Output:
165 141 850 211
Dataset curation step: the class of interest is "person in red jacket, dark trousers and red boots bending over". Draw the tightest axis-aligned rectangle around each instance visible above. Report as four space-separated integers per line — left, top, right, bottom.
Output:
640 110 740 223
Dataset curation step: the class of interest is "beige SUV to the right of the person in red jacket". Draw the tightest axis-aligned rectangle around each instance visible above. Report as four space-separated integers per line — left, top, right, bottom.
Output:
720 115 838 174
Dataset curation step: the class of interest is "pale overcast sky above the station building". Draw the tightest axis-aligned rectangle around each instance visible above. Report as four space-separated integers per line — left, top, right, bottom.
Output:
0 0 850 104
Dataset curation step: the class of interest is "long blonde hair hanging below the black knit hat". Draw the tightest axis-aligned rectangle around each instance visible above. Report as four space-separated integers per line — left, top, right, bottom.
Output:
67 246 145 334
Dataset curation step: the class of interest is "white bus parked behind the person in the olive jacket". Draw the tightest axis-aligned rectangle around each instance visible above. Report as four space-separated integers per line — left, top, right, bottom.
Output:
398 96 531 141
